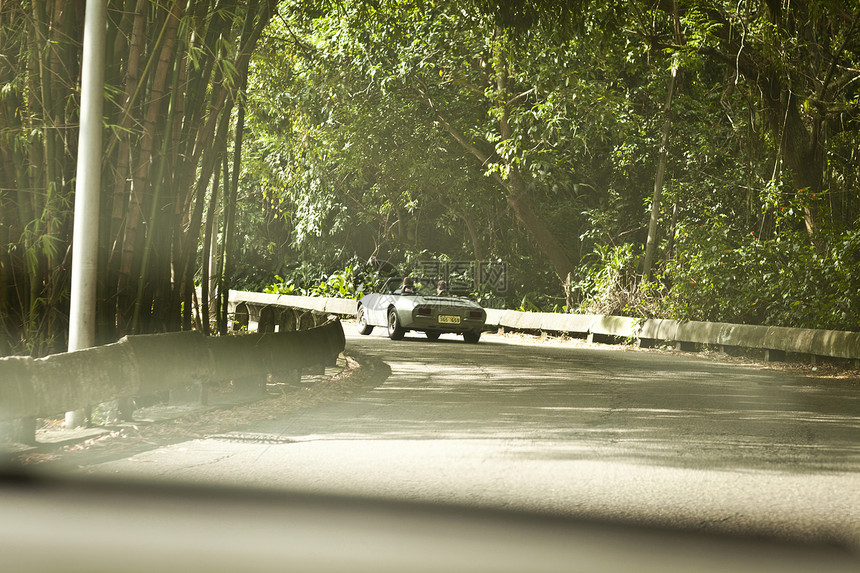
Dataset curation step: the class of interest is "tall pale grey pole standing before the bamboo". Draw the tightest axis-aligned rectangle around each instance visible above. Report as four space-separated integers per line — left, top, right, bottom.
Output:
66 0 107 428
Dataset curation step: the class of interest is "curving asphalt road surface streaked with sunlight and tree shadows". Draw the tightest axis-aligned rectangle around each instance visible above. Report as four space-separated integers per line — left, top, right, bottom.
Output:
82 326 860 546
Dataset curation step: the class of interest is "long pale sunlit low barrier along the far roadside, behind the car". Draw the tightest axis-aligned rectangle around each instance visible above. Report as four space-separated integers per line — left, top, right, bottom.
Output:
230 291 860 366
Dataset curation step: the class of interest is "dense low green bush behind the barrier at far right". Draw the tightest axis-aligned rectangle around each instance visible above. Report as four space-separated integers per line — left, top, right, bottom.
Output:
661 226 860 330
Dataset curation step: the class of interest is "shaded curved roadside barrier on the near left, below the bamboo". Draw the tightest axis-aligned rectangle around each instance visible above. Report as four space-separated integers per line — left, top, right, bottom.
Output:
0 317 345 421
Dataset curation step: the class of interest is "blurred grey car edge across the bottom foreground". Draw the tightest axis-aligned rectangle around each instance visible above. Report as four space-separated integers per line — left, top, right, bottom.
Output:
0 472 860 573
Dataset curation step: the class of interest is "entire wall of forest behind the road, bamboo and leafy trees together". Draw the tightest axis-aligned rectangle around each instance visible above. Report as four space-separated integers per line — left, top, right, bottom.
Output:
0 0 860 354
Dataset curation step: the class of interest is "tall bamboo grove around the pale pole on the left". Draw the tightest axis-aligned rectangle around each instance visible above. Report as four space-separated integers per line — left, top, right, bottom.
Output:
0 0 275 355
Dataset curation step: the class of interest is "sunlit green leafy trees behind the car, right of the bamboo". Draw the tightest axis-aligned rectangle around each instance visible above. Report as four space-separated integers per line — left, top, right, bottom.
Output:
223 0 860 328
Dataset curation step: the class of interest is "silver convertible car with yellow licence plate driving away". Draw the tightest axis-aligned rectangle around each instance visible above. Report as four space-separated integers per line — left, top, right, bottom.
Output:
356 278 487 344
